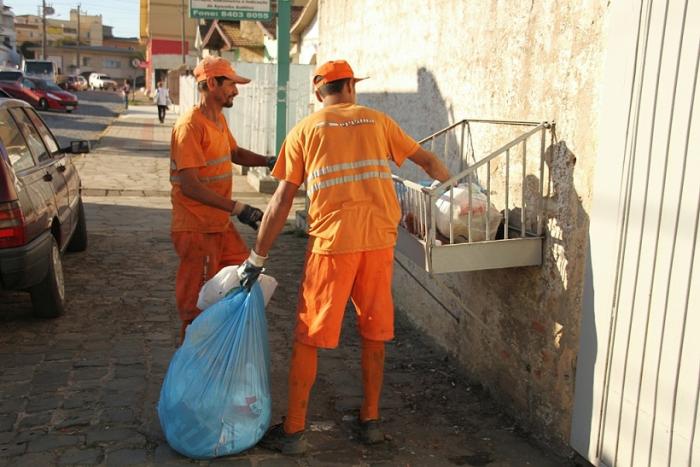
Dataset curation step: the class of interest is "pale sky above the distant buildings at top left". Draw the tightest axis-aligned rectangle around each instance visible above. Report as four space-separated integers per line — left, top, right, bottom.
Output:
4 0 139 37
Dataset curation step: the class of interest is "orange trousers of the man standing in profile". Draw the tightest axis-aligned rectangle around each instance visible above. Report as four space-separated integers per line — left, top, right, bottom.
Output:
171 223 249 321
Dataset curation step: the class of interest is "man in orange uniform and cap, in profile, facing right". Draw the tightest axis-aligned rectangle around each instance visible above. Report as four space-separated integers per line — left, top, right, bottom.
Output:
170 57 275 343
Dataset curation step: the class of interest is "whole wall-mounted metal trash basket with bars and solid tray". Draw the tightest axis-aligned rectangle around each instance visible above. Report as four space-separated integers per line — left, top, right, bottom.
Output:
393 119 554 273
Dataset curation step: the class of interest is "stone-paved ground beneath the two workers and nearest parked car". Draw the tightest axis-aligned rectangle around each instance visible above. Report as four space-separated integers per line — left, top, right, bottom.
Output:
0 107 568 466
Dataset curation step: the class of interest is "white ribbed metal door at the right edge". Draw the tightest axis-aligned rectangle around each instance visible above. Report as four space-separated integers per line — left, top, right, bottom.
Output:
571 0 700 467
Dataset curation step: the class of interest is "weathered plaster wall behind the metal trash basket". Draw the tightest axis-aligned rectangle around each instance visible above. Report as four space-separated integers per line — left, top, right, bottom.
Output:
318 0 608 454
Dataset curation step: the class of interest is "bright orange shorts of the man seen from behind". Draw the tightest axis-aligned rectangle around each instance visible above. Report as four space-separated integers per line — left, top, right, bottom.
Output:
295 248 394 349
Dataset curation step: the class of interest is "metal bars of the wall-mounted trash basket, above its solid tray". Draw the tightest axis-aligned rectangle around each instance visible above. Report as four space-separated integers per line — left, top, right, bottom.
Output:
393 119 554 247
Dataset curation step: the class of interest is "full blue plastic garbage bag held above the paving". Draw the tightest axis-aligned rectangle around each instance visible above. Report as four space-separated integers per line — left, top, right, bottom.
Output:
158 283 272 459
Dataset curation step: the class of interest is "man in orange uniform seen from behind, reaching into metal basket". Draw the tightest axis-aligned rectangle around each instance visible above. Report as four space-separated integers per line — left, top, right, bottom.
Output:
238 60 450 454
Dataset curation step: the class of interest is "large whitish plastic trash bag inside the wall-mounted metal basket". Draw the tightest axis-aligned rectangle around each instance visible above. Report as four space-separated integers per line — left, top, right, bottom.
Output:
435 183 503 243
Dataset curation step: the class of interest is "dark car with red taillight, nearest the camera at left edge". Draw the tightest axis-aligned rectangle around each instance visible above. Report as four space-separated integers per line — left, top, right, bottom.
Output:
0 98 89 318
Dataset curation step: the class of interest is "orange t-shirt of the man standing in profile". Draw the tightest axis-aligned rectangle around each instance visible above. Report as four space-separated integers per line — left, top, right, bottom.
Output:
170 107 237 233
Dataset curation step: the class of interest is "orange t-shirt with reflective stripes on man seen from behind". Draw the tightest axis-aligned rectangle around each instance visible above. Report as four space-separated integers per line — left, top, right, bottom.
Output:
272 104 419 254
